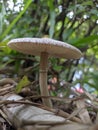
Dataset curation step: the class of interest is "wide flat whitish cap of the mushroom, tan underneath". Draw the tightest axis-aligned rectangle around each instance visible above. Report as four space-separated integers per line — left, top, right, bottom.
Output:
8 38 82 59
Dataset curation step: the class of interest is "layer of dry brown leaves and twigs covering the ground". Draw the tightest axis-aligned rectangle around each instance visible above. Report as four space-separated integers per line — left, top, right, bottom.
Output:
0 78 98 130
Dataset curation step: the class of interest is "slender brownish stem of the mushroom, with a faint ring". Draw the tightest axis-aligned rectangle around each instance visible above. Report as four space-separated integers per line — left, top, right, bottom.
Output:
39 52 52 108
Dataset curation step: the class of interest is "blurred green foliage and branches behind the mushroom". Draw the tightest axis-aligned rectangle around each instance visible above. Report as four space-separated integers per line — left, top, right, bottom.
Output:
0 0 98 97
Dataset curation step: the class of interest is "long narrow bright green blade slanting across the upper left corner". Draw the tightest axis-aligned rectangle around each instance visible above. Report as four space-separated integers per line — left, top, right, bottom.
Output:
1 0 32 39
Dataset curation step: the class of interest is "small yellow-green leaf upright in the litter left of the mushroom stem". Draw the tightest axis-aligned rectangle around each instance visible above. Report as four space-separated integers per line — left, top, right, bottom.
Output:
16 76 30 93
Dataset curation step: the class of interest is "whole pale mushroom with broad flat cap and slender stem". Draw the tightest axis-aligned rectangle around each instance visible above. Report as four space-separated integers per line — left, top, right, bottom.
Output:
8 38 82 107
